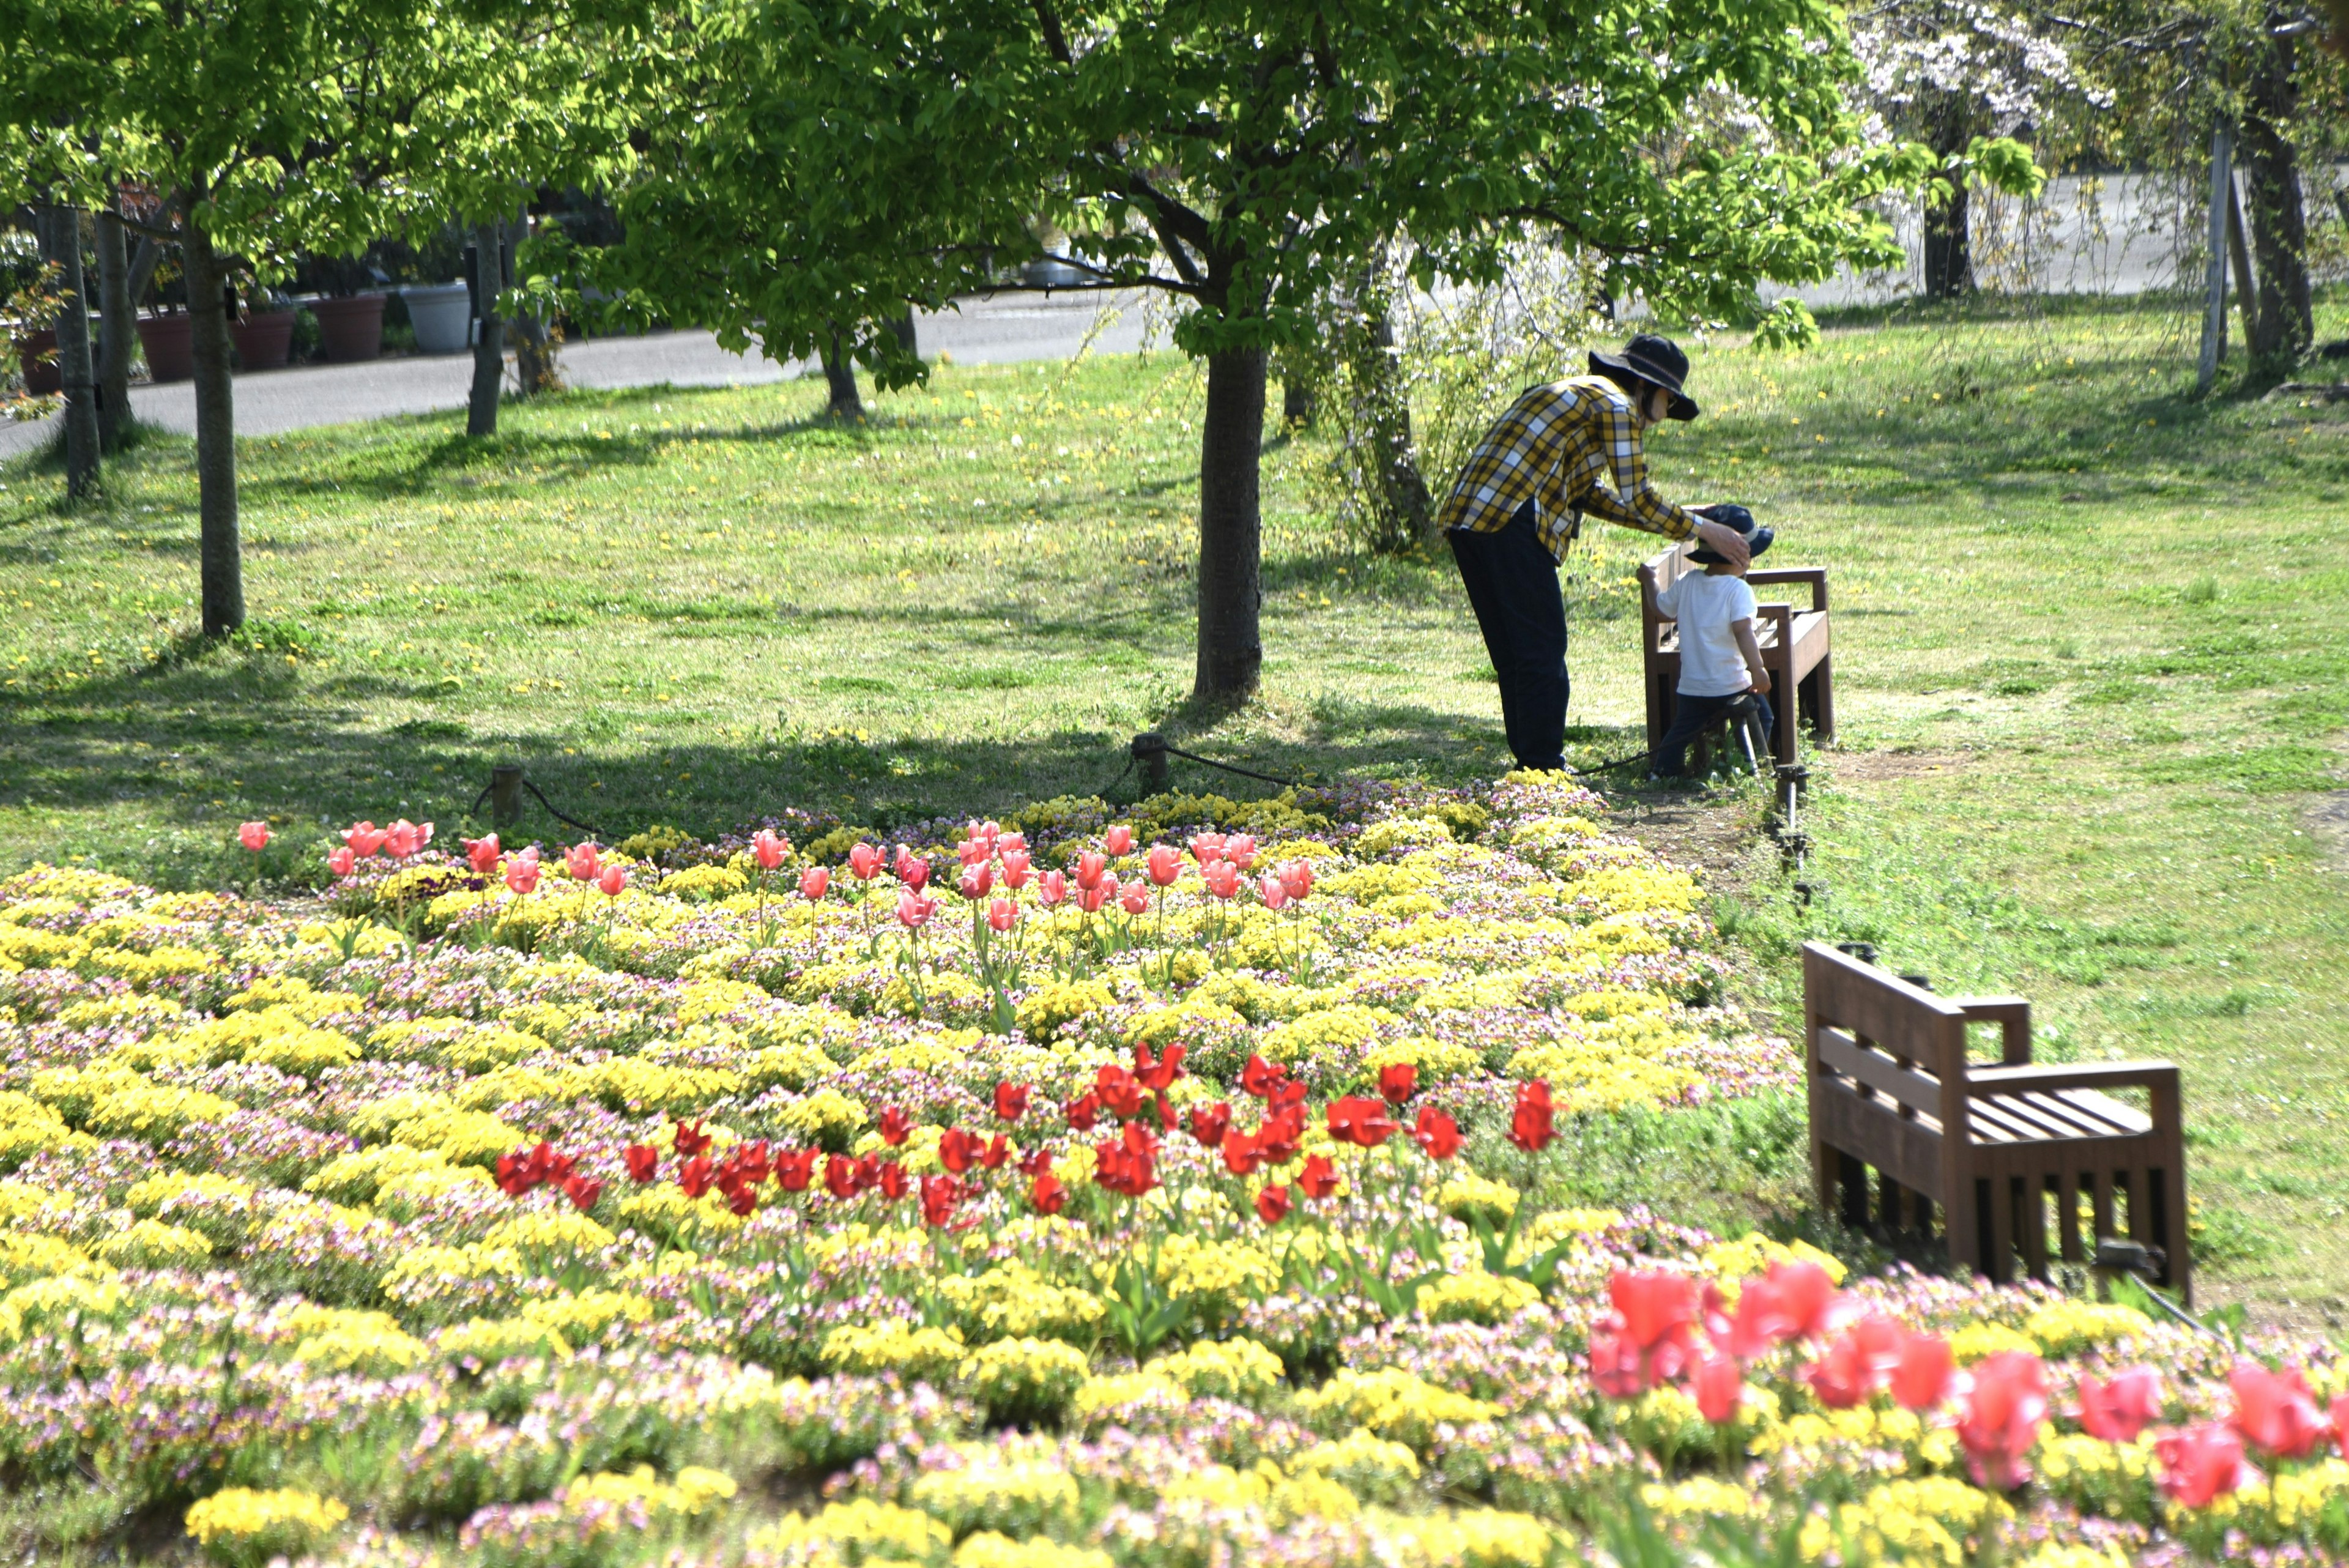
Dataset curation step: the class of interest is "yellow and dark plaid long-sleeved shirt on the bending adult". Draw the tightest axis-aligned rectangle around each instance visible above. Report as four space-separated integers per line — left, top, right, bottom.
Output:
1435 376 1696 560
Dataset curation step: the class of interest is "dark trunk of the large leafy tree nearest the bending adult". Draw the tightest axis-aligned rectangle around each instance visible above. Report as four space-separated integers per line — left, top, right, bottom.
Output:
1191 348 1264 708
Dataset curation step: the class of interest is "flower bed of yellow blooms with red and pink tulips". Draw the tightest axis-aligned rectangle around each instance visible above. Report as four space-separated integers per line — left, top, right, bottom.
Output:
0 778 2349 1568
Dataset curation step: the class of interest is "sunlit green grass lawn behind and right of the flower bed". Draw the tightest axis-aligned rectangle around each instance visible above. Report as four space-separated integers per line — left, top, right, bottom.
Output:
0 294 2349 1319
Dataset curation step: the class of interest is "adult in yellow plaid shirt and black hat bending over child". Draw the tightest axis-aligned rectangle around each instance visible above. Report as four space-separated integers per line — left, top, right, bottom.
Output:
1438 332 1745 769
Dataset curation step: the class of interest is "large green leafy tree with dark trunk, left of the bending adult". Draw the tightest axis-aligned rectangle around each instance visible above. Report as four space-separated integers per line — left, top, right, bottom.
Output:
587 0 1924 703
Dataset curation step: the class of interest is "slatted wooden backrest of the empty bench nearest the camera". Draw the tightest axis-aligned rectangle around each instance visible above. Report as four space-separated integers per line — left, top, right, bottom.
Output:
1802 943 1966 1142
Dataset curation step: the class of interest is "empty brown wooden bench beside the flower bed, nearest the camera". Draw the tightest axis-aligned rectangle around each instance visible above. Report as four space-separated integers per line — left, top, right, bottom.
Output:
1802 943 2194 1305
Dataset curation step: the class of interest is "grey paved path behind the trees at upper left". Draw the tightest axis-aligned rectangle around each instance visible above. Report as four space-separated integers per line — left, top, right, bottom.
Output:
0 291 1146 458
